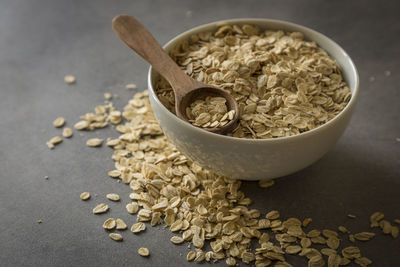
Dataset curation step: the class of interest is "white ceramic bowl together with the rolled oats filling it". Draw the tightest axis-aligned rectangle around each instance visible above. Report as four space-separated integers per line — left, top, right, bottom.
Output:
148 19 359 180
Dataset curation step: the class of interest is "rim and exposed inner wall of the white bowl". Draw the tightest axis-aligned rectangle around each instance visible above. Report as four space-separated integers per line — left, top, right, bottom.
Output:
148 19 359 142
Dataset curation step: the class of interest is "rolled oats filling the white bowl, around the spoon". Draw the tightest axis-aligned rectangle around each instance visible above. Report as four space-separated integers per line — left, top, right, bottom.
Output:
156 25 351 139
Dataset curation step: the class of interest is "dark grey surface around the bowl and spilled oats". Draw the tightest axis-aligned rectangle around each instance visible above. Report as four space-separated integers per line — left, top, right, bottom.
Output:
0 0 400 266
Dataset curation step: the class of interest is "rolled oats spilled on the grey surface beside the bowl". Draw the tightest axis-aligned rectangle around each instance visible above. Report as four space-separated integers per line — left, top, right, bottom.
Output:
50 83 400 267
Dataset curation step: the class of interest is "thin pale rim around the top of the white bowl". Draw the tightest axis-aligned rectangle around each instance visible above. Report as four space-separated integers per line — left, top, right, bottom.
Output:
147 18 360 144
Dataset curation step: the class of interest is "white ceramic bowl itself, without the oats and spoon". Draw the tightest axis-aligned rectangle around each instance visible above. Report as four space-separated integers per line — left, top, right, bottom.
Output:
148 19 359 180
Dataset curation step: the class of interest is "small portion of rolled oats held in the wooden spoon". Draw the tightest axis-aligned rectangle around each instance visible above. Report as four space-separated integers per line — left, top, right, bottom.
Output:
186 96 235 128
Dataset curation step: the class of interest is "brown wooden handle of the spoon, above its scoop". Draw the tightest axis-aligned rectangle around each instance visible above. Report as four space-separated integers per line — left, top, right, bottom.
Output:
112 15 198 95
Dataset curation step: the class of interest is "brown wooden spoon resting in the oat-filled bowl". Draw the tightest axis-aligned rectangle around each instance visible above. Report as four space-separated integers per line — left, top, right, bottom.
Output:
112 15 239 133
